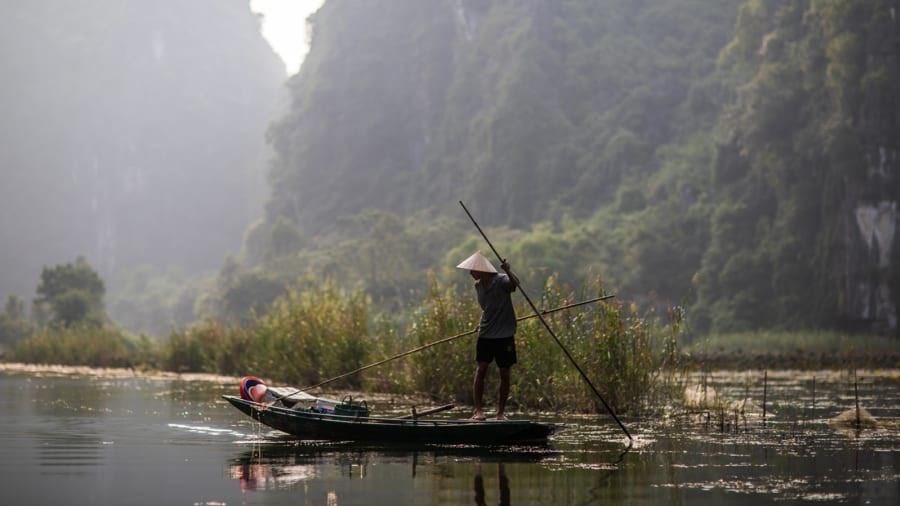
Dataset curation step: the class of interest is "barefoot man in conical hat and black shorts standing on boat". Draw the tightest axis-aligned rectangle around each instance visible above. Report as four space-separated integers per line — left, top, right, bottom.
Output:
456 251 519 420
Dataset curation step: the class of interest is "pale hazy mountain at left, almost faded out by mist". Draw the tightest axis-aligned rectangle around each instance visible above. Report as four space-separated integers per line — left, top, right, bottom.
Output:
0 0 285 304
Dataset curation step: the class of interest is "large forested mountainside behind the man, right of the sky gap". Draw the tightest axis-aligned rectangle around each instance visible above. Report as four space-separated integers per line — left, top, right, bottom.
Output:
248 0 900 331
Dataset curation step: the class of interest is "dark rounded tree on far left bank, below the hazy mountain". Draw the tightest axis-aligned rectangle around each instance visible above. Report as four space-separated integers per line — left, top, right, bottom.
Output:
35 257 106 327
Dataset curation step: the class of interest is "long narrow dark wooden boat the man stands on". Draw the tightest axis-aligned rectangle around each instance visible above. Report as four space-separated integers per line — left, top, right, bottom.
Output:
223 395 558 445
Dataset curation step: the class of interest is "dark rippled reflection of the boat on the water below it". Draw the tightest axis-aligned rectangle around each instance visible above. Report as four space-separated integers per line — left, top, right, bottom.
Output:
227 435 630 498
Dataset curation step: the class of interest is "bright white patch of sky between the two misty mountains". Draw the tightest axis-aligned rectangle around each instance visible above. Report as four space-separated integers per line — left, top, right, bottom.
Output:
250 0 324 74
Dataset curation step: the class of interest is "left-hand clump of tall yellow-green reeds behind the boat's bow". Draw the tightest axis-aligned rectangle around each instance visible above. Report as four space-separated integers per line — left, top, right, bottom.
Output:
162 280 370 387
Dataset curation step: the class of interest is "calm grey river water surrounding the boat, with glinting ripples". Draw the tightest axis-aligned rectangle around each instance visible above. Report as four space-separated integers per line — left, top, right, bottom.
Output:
0 365 900 506
